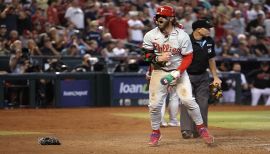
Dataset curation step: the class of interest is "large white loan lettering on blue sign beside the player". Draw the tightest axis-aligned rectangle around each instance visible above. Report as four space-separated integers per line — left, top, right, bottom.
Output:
119 82 148 94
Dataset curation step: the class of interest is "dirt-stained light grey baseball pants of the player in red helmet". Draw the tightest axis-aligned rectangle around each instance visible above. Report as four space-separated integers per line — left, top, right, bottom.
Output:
148 70 203 130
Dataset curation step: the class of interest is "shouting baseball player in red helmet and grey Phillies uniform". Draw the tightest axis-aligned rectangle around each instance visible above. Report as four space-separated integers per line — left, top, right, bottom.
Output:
142 5 214 146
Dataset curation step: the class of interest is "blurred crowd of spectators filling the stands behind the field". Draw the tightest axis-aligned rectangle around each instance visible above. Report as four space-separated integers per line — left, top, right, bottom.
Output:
0 0 270 106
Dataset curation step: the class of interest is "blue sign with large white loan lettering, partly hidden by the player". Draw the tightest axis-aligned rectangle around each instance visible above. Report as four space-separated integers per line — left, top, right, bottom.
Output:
112 75 149 106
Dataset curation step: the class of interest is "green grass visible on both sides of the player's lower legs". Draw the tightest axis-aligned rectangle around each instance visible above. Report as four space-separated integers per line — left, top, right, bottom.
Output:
114 111 270 130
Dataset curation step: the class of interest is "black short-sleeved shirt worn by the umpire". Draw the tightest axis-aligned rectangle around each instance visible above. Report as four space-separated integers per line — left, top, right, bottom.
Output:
187 33 216 75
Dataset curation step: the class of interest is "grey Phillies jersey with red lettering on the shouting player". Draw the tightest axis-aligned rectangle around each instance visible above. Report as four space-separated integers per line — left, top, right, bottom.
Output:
143 27 193 71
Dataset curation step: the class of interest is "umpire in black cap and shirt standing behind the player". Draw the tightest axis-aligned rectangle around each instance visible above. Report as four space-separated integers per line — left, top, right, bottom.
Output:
180 19 221 139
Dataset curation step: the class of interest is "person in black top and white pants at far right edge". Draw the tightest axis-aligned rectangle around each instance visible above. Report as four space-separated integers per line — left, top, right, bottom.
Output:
248 62 270 106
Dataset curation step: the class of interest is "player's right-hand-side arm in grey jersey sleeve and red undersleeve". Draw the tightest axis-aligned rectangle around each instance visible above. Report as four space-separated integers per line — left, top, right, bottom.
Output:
177 33 193 73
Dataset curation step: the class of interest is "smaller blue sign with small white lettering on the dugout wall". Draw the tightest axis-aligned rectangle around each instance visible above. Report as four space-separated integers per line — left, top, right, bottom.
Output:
60 80 93 107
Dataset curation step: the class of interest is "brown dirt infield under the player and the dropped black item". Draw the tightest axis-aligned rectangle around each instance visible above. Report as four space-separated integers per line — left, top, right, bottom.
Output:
0 106 270 154
